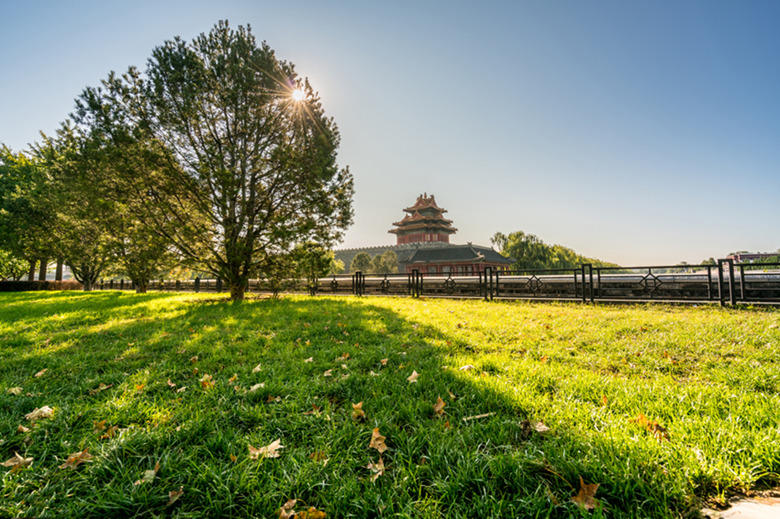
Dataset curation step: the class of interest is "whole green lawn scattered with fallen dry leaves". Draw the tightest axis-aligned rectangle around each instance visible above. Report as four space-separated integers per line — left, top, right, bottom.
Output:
0 292 780 518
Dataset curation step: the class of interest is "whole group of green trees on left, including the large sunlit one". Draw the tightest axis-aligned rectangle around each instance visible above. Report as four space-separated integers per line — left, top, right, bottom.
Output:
0 21 354 300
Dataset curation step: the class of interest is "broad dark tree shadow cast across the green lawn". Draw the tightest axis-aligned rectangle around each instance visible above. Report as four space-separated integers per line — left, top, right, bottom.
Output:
0 294 760 517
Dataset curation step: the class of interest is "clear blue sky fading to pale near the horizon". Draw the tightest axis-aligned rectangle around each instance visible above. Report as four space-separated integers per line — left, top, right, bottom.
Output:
0 0 780 266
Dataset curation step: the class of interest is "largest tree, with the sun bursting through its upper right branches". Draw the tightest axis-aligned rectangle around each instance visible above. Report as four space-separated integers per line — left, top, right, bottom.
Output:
80 22 353 300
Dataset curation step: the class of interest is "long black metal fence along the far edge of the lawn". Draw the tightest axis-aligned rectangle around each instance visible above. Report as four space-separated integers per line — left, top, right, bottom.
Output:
99 259 780 305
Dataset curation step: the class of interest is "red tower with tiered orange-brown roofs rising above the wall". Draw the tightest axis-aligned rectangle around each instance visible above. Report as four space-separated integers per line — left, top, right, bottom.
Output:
387 193 458 245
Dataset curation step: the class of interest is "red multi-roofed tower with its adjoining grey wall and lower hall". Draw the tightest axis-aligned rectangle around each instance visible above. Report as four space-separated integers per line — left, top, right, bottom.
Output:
335 193 514 274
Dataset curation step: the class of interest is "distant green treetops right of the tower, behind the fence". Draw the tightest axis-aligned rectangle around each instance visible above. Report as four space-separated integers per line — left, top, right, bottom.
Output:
491 231 618 270
